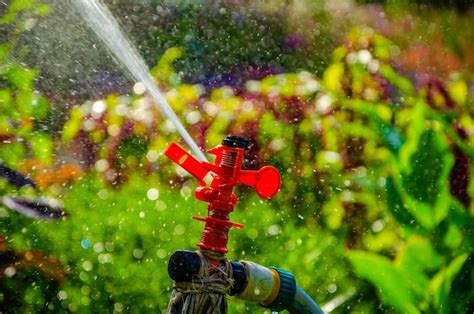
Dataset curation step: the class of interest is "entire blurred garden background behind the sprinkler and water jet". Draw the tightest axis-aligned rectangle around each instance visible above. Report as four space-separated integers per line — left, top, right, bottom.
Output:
0 0 474 313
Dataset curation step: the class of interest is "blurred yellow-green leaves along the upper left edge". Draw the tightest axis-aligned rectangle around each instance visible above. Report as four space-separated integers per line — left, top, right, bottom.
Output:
0 0 52 167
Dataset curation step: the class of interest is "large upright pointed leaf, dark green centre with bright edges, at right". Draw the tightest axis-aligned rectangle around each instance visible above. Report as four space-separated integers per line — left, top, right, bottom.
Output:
394 101 454 230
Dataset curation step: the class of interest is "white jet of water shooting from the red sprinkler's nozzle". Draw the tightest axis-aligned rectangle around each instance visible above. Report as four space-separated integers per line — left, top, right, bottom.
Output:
70 0 206 161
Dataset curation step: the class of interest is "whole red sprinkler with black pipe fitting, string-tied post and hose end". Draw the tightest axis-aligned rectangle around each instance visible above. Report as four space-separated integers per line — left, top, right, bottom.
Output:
165 135 323 314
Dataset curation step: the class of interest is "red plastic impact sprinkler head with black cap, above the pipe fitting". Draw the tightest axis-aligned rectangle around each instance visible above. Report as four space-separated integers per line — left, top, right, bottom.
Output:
165 135 281 253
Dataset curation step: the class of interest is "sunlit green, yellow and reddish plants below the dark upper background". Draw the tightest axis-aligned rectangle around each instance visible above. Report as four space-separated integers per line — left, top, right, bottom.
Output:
0 0 474 313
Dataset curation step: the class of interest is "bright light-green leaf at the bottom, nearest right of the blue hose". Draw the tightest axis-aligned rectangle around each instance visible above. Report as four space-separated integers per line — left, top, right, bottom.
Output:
348 251 420 313
